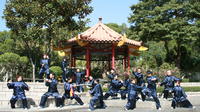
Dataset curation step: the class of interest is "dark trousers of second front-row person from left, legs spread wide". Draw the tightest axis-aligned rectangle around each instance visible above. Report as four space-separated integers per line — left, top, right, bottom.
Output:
40 92 62 107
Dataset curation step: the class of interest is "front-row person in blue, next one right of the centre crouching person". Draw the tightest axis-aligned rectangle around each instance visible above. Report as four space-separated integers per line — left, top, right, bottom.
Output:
125 79 142 110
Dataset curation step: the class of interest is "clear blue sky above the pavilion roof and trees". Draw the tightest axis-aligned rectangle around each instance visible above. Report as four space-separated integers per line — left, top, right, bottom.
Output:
0 0 138 31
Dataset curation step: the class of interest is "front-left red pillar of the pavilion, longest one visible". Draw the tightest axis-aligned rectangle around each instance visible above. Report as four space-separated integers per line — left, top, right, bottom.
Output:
86 46 90 77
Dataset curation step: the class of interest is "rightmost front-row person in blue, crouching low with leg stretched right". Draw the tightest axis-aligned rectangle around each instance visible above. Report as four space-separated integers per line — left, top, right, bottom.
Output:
171 79 193 109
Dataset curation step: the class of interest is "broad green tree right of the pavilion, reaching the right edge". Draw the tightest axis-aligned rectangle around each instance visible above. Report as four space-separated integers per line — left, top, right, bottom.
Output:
129 0 200 68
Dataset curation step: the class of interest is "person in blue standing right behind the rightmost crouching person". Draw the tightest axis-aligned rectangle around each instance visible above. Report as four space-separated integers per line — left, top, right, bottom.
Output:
160 70 178 99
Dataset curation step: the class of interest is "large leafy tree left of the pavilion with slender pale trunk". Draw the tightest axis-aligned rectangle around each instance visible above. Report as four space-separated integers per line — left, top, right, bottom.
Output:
4 0 92 79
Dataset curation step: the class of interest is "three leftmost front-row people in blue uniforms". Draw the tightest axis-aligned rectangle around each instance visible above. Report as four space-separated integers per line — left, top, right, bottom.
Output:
7 73 84 109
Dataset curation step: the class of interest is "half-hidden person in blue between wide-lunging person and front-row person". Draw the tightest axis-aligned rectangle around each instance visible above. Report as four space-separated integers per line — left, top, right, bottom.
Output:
121 73 131 99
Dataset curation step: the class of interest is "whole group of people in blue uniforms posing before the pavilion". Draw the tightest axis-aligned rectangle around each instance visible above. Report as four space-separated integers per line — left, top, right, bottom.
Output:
7 60 193 110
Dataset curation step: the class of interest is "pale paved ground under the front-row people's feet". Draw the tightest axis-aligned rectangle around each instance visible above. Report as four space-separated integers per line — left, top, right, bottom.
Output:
0 92 200 112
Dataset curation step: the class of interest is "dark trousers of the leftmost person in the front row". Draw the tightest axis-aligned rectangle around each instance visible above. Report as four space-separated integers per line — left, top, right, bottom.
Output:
10 96 28 108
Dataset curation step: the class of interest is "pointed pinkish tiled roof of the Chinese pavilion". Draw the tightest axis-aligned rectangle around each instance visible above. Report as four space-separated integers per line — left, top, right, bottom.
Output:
67 18 142 46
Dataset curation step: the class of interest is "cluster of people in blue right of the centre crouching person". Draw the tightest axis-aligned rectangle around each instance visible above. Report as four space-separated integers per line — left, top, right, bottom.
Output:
101 68 193 110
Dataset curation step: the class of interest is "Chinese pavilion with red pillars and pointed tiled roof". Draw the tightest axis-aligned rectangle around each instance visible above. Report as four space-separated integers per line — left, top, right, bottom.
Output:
54 18 148 76
